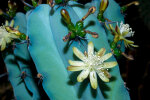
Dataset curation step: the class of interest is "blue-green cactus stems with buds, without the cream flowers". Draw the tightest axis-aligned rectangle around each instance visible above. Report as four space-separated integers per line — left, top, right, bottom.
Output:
0 0 130 100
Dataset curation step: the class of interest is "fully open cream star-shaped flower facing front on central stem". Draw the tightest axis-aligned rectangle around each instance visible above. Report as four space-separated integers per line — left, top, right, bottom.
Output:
68 42 117 89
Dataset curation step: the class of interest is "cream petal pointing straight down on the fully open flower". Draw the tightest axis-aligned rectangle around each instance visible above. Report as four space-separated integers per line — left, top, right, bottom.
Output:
90 71 97 89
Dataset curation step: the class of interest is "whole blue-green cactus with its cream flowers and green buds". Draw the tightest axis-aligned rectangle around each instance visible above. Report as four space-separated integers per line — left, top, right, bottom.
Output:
0 0 133 100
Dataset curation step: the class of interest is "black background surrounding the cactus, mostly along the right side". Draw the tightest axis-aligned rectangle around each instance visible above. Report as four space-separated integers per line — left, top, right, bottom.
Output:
0 0 150 100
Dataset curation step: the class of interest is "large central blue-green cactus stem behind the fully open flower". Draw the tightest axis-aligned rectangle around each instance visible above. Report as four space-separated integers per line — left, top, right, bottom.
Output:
27 2 130 100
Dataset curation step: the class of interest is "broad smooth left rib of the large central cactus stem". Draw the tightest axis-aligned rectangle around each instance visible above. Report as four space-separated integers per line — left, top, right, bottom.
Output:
27 4 78 100
